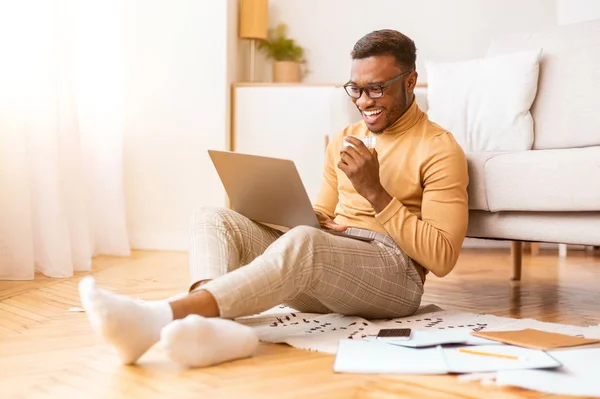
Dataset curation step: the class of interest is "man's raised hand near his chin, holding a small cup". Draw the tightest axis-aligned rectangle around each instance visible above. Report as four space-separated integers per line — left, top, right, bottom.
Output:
338 136 392 213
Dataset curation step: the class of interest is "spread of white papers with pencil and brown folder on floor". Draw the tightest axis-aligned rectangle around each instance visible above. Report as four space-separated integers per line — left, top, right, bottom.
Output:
333 329 600 397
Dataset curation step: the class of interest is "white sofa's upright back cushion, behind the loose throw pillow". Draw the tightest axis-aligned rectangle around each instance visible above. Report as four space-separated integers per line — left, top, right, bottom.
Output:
488 20 600 149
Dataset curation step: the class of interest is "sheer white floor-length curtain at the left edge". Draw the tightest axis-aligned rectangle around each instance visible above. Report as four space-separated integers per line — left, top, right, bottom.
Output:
0 0 129 280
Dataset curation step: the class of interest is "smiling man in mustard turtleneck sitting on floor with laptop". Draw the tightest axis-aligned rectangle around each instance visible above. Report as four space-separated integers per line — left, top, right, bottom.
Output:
80 30 468 366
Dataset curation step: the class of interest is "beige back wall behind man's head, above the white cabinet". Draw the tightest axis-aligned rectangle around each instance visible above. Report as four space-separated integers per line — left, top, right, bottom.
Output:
242 0 556 83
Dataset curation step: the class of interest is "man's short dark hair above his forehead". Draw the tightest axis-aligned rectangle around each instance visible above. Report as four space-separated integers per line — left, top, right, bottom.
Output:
350 29 417 69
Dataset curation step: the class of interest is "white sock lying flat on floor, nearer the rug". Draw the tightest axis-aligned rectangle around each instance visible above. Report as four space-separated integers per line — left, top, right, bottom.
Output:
160 315 258 367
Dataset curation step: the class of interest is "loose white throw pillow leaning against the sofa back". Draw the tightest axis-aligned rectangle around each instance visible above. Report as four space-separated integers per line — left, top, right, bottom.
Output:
425 49 541 152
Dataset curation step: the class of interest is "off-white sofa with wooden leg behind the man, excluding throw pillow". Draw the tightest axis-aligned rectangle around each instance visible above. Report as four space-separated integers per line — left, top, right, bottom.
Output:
446 21 600 280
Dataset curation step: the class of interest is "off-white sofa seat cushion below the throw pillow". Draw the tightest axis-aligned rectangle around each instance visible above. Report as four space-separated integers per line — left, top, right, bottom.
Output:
485 147 600 212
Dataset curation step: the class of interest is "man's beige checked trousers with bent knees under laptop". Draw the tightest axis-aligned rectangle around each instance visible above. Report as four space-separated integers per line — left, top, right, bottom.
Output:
190 208 423 319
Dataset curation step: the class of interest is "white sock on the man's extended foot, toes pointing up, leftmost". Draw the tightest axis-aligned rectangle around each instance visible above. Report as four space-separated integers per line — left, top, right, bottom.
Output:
79 277 173 364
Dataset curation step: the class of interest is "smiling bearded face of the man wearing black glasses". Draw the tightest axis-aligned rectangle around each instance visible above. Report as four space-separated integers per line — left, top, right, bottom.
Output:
349 55 416 134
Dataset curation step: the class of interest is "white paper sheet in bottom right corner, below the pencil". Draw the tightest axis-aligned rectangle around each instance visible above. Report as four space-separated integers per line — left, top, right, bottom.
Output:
496 348 600 397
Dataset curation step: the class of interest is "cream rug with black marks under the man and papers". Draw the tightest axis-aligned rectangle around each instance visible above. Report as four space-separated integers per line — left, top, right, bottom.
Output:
236 305 600 353
